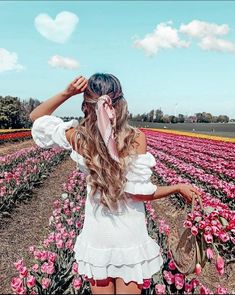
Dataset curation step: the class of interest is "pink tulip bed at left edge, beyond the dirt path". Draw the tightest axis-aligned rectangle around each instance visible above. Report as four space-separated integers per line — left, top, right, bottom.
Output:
0 147 70 216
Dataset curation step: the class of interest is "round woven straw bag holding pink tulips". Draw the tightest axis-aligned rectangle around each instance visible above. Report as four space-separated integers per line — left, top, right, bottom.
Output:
168 192 206 274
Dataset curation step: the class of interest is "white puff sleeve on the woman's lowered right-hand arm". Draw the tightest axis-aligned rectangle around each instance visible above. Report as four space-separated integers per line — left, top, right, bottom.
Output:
124 152 157 195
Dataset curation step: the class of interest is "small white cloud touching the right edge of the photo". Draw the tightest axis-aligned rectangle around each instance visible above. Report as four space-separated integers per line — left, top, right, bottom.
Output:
198 36 235 52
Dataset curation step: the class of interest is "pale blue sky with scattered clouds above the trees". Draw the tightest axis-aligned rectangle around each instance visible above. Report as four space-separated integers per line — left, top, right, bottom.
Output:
0 1 235 118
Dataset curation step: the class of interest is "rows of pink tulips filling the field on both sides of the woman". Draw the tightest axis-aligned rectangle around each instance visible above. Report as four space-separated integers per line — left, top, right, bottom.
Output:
0 128 235 294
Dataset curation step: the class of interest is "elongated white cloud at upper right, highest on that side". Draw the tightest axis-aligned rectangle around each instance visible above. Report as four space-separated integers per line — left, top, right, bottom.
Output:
179 20 229 38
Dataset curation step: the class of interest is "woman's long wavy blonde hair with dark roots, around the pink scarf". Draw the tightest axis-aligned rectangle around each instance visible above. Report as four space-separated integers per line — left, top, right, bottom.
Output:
72 73 139 214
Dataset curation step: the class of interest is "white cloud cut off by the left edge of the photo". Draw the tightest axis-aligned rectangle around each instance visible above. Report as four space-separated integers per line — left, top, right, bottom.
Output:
0 48 24 72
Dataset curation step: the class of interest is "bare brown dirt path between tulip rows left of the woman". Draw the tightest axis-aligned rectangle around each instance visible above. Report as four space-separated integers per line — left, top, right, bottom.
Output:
0 157 75 294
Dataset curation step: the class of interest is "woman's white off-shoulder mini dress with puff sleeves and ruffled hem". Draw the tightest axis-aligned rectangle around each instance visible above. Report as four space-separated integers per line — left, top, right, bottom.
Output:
31 115 163 284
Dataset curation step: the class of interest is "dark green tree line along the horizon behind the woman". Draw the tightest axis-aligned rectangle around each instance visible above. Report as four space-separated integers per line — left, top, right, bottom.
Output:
0 95 231 129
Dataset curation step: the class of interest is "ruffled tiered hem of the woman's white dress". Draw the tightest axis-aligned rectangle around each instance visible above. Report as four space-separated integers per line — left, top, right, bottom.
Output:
74 234 163 284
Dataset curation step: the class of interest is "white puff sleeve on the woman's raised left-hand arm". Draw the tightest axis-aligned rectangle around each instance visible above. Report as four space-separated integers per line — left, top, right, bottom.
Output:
31 115 79 150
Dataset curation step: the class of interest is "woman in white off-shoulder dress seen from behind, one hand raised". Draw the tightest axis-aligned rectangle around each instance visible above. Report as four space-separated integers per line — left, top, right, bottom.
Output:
30 73 200 294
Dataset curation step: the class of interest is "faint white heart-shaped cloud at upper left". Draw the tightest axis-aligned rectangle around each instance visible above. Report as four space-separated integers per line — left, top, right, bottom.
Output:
34 11 78 43
